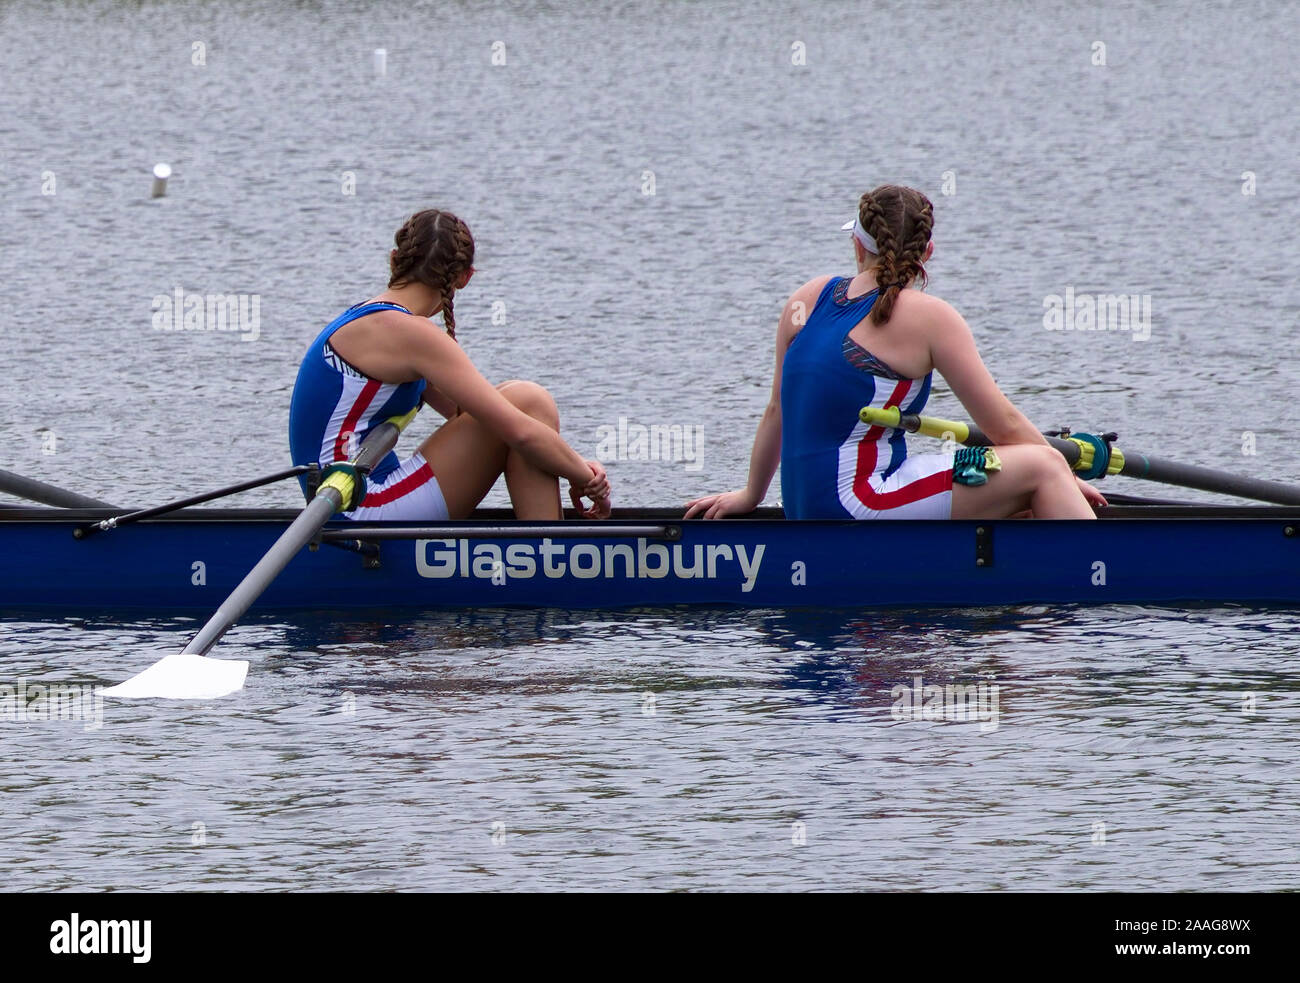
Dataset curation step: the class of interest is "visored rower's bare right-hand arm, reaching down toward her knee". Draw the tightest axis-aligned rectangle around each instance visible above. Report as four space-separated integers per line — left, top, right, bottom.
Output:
927 298 1047 443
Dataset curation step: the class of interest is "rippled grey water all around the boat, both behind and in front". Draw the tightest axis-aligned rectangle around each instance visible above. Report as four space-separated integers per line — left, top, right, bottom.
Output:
0 1 1300 891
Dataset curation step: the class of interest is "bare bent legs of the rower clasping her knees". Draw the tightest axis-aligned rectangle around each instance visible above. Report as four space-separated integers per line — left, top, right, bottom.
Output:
420 380 562 520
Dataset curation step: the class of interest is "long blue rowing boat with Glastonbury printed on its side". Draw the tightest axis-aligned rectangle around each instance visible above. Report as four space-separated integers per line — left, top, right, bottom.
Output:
0 505 1300 614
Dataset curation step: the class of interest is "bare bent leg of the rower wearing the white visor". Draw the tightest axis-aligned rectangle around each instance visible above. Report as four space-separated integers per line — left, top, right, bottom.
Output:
953 443 1097 519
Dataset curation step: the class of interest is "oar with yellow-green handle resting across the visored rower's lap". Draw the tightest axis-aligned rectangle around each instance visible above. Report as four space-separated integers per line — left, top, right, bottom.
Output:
858 406 1300 505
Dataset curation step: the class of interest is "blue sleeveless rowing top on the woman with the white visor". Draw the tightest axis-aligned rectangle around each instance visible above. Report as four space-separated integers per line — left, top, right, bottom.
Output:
781 277 933 519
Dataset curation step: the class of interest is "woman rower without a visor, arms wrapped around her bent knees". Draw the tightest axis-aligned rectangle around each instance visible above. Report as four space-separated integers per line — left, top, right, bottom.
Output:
289 208 610 521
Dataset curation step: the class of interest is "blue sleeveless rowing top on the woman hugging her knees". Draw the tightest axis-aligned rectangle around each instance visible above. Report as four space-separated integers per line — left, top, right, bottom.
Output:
289 303 425 495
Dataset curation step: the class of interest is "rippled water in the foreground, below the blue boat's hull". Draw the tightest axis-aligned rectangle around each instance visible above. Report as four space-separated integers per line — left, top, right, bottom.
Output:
0 609 1300 889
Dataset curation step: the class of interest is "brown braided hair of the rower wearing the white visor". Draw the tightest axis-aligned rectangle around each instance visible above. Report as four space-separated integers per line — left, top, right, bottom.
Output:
858 185 935 324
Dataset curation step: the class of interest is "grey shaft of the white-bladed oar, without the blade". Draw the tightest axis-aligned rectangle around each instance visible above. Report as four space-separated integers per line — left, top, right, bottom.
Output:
182 412 403 655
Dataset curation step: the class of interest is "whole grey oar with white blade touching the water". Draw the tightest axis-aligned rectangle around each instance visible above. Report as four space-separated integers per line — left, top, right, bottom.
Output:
104 407 419 700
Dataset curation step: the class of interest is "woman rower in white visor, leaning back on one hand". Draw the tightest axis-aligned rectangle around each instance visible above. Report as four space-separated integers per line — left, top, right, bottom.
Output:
686 185 1105 519
